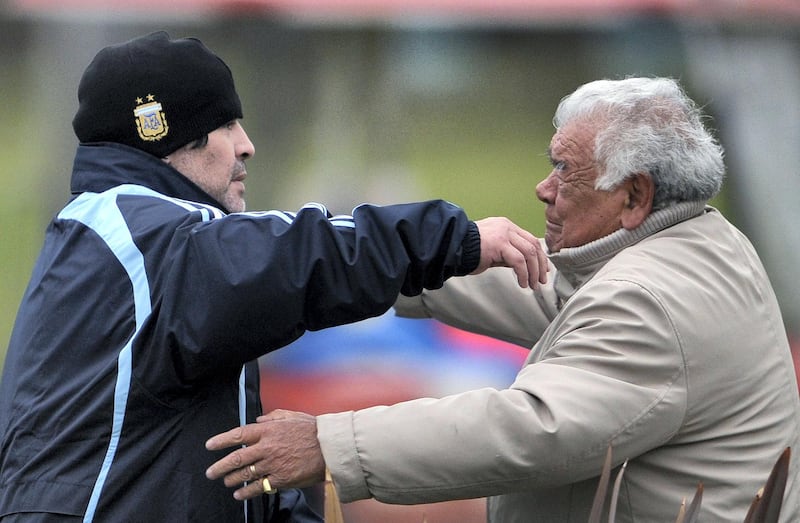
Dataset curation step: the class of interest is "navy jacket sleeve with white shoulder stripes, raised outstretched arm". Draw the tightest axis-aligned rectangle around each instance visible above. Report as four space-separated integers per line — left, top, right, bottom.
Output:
144 201 480 382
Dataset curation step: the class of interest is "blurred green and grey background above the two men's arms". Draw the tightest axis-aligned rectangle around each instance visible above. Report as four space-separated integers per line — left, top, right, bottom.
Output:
0 0 800 376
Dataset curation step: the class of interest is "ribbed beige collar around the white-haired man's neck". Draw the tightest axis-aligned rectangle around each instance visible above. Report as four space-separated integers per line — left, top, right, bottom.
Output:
549 201 706 303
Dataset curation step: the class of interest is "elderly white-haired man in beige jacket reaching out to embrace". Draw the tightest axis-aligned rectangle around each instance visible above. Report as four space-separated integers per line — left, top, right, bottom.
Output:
207 78 800 523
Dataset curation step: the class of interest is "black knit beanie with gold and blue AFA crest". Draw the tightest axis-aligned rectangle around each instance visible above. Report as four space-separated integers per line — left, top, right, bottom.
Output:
72 31 242 158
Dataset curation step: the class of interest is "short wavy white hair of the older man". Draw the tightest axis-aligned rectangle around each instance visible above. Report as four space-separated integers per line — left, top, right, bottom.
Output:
553 78 725 209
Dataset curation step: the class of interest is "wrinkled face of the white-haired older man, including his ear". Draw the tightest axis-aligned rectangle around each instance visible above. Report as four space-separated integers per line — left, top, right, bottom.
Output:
536 121 628 253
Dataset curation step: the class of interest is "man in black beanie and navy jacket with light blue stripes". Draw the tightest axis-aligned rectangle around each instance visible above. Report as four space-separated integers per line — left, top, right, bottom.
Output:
0 32 546 523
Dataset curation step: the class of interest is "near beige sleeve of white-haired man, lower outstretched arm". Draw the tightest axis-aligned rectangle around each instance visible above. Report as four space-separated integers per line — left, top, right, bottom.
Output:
317 282 687 504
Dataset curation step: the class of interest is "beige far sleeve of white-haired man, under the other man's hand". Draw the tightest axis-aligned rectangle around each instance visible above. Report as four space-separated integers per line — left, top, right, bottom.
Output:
394 266 558 348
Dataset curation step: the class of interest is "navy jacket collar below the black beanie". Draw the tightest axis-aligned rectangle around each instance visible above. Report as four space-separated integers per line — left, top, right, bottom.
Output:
70 142 227 212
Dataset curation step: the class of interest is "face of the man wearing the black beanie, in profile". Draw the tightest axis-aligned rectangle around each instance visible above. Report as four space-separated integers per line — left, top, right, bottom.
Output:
166 120 255 212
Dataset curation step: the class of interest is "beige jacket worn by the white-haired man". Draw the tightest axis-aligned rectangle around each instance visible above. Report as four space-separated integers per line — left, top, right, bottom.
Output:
318 204 800 523
